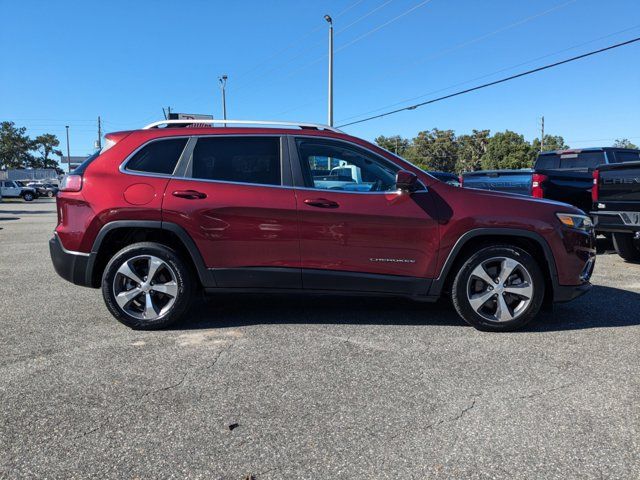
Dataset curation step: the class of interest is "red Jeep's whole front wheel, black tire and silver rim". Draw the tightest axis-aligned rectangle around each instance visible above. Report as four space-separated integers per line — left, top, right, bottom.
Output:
451 245 545 331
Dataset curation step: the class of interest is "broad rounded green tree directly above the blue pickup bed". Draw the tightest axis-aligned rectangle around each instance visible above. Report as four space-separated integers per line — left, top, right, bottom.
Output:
482 130 537 170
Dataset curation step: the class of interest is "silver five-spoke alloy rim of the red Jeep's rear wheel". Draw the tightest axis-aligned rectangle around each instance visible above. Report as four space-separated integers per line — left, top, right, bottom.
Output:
113 255 178 320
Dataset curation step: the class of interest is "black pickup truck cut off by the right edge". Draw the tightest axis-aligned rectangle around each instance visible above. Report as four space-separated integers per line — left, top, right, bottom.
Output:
591 161 640 262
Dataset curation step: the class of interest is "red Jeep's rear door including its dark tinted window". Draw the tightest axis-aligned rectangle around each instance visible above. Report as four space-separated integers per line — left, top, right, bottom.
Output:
163 135 301 288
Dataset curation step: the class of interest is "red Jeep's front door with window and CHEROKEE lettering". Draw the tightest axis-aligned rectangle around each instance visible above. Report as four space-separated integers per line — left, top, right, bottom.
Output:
292 137 438 294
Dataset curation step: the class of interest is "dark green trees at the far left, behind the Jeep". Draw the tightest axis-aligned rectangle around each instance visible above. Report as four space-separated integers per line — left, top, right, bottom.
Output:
0 121 62 173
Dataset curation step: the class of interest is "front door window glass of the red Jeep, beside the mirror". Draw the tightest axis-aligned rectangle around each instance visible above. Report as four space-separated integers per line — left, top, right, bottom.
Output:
296 138 399 192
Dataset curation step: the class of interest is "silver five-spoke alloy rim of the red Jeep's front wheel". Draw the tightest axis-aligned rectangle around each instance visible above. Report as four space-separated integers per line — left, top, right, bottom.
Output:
467 257 534 322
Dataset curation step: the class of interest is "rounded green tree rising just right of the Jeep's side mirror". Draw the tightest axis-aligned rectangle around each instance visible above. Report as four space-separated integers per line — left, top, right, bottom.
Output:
406 128 458 172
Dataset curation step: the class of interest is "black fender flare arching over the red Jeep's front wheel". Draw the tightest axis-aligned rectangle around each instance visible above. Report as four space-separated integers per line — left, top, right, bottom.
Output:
429 228 558 296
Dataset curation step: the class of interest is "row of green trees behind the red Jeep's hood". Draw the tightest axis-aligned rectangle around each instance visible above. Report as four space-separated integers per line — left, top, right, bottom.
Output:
375 128 637 173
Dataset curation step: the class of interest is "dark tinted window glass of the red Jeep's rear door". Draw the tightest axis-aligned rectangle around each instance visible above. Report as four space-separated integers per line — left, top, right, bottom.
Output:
191 137 281 185
